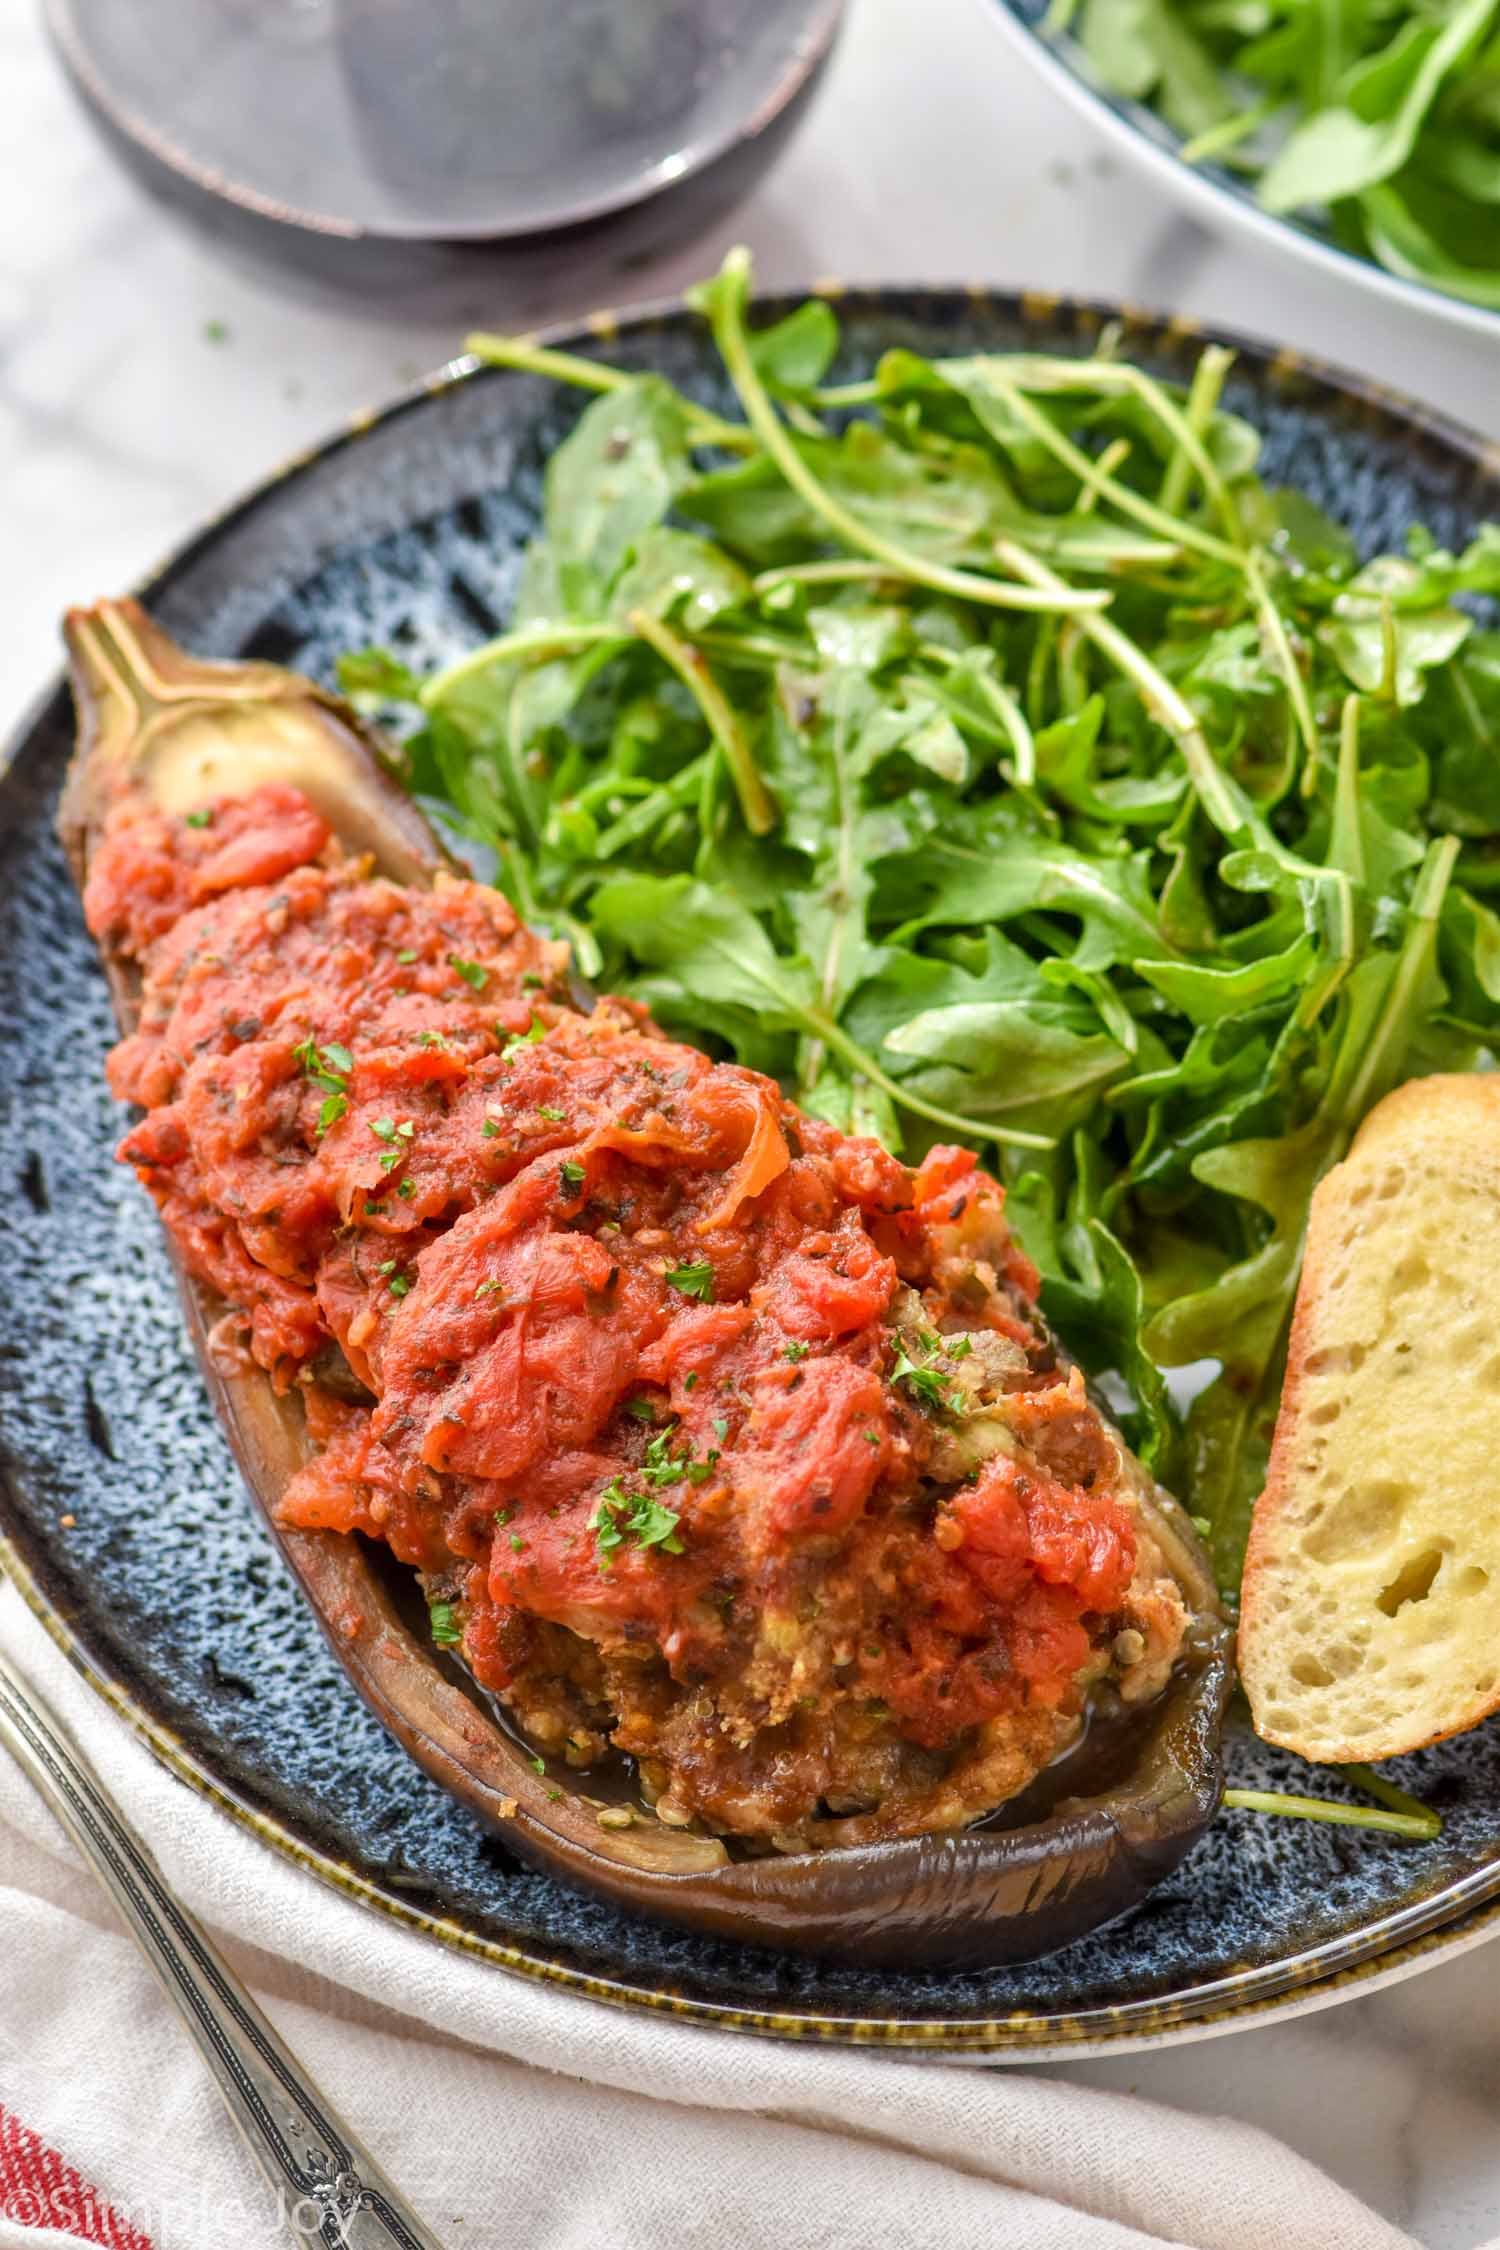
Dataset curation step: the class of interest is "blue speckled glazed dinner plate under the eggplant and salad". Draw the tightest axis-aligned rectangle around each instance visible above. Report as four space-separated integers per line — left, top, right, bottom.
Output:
0 290 1500 2054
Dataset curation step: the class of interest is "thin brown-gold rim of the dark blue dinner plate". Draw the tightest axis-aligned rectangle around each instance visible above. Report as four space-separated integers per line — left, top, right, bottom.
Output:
0 279 1500 2061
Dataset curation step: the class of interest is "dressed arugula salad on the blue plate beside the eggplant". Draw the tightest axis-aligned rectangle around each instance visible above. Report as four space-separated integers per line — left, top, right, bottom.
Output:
342 252 1500 1598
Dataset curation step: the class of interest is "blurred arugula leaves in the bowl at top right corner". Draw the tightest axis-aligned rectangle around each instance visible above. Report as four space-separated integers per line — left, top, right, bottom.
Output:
1043 0 1500 308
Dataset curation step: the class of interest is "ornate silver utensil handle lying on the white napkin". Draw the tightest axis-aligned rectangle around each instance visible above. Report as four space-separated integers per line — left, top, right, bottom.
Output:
0 1656 443 2250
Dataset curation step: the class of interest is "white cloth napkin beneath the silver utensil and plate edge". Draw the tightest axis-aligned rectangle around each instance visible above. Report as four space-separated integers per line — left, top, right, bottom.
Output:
0 1586 1412 2250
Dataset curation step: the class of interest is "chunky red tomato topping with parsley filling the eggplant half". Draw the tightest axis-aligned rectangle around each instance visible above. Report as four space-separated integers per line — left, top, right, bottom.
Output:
85 785 1181 1841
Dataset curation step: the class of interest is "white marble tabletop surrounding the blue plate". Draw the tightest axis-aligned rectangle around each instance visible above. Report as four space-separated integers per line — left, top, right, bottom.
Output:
0 0 1500 2250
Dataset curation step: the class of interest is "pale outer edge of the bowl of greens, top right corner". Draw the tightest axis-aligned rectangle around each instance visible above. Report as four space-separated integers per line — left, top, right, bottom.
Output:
985 0 1500 342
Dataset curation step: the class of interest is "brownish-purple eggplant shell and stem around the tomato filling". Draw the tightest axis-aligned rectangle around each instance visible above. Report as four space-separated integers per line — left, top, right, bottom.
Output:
58 601 1232 1967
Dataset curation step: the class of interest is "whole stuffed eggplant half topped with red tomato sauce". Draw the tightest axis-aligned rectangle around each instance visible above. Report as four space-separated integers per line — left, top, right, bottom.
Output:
61 603 1228 1962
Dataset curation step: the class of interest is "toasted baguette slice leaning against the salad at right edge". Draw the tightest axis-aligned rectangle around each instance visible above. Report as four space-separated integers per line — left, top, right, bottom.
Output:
1239 1076 1500 1760
